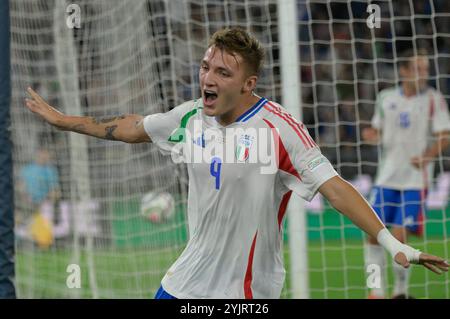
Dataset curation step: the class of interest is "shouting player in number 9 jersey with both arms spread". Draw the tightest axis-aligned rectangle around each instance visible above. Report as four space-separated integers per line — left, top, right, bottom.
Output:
26 28 449 298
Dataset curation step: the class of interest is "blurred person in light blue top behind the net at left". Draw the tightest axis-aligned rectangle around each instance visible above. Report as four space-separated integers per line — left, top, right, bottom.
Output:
16 138 60 248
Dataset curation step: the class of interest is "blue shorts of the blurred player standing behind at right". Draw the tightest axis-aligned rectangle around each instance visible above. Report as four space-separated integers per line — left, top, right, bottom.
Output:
370 186 425 235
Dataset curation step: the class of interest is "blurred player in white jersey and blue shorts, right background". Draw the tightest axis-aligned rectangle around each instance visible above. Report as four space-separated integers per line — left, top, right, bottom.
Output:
362 49 450 299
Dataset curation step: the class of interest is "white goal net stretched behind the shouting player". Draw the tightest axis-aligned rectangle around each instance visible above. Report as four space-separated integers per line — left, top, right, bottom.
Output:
10 0 450 298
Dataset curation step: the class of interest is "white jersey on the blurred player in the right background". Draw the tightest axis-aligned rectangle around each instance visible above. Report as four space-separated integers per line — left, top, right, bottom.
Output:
372 88 450 190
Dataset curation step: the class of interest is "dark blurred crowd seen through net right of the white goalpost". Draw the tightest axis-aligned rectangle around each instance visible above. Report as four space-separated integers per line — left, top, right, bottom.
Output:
299 0 450 178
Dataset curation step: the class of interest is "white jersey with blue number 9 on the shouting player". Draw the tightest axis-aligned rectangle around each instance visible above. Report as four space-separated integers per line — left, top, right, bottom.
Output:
144 98 337 298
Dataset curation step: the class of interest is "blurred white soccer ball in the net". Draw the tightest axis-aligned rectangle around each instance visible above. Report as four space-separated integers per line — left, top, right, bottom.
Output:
141 192 175 224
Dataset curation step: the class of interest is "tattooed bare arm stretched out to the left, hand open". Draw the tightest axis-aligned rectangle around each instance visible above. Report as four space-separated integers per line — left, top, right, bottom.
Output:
25 88 151 143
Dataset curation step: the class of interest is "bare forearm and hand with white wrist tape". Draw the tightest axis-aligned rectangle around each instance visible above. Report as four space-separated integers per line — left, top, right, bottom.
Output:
319 176 449 274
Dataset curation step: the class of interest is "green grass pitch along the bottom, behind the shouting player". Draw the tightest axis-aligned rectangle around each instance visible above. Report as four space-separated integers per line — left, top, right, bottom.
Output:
16 241 450 298
